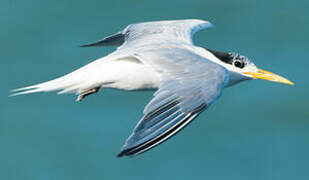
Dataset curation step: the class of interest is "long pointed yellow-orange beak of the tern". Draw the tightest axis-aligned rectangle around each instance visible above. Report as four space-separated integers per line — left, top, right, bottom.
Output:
244 69 294 85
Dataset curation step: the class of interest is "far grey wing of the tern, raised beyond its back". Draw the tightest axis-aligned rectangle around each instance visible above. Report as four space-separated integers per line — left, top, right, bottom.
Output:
81 19 212 47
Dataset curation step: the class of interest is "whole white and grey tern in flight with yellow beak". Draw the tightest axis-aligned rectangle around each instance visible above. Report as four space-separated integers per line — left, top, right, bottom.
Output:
12 19 293 157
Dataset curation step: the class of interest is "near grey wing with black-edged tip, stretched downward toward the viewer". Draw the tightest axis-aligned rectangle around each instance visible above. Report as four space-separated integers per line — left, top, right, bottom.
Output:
118 48 228 157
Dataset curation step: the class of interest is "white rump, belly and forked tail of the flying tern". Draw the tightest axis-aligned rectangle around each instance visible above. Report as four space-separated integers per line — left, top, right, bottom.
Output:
10 56 160 96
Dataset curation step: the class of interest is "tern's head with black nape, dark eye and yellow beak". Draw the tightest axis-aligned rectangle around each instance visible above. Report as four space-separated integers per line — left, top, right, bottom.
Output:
207 49 294 86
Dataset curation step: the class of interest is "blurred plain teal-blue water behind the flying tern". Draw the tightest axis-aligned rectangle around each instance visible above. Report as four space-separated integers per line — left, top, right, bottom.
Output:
0 0 309 180
